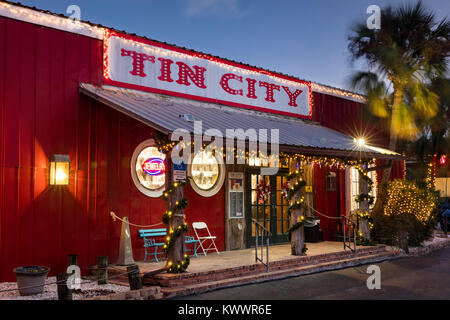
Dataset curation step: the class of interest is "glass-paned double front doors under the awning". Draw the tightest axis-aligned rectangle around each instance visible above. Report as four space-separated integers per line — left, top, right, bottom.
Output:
245 170 289 247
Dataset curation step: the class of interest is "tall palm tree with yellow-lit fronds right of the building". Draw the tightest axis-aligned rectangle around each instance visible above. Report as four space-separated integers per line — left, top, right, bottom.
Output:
348 1 450 183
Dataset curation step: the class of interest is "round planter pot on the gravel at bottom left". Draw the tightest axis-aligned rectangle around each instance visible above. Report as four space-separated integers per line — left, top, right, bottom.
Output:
13 266 50 296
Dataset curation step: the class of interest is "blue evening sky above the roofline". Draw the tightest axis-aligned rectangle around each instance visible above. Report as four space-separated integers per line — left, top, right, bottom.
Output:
11 0 450 89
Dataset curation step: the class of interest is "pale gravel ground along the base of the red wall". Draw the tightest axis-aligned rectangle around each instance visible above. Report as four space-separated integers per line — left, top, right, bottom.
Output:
0 277 130 300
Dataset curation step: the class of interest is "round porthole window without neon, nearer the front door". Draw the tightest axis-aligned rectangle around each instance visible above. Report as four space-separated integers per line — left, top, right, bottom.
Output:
188 151 225 197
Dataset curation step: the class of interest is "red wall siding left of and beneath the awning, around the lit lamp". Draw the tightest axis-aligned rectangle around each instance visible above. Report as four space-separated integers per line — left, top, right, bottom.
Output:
0 18 225 281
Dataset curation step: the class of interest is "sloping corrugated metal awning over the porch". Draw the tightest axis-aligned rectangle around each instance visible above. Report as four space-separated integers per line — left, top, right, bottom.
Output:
80 83 403 159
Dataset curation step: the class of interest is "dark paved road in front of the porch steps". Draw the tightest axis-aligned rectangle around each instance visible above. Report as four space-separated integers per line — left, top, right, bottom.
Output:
181 248 450 300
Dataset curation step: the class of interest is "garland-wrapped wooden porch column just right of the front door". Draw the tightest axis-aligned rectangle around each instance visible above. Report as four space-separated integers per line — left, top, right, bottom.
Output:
286 169 306 256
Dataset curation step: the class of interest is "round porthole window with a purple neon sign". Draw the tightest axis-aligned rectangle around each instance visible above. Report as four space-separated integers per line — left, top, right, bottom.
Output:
131 139 166 197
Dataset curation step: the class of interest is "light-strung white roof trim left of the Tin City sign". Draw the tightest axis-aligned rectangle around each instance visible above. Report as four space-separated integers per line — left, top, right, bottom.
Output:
0 2 103 40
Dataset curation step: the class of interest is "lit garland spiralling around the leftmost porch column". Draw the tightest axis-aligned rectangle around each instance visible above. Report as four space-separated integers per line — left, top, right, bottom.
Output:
161 180 190 273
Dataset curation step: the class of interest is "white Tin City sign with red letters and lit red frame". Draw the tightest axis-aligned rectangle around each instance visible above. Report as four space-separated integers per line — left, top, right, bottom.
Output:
103 30 311 119
